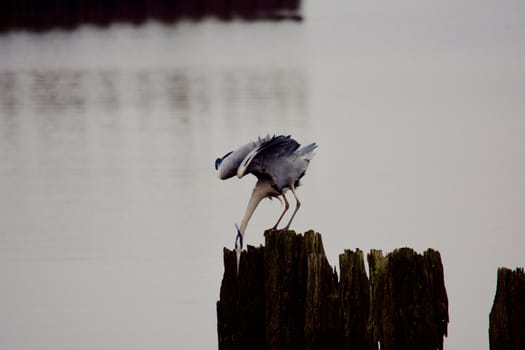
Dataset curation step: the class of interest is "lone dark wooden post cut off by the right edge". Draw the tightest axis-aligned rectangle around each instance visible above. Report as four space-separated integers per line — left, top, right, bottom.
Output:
489 267 525 350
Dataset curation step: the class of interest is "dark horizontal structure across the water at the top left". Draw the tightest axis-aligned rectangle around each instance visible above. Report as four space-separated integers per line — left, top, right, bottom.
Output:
0 0 302 32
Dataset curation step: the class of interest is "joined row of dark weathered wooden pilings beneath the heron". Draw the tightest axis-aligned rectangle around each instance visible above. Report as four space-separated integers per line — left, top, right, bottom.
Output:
217 230 448 350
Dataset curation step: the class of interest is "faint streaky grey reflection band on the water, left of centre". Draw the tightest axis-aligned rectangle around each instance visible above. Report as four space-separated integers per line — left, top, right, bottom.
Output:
0 69 306 116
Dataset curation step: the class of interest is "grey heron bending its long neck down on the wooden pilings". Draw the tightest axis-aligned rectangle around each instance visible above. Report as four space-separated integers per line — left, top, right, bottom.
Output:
215 135 317 266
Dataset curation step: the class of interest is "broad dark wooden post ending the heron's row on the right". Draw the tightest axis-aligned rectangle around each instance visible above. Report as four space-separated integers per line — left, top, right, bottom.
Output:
368 248 449 350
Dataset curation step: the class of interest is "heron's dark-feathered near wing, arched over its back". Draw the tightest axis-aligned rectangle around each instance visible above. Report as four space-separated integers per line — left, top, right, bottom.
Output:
237 135 300 178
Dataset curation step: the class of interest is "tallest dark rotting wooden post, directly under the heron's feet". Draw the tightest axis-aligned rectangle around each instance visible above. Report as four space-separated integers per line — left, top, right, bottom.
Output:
264 230 340 349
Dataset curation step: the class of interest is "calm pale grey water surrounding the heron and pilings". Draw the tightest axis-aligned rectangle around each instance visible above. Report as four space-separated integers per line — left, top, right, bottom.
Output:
0 0 525 350
